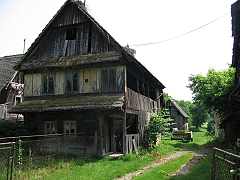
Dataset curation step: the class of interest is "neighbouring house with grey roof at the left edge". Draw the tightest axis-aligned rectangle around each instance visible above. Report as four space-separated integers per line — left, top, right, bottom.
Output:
0 54 24 121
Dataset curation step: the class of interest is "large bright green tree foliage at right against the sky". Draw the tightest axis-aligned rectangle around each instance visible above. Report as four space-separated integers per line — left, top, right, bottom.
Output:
187 68 235 118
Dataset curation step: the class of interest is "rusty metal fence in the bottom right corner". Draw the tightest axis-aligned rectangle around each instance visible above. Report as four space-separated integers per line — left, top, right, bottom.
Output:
211 148 240 180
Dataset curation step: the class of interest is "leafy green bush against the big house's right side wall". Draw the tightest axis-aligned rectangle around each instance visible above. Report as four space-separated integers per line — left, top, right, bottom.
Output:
146 108 173 147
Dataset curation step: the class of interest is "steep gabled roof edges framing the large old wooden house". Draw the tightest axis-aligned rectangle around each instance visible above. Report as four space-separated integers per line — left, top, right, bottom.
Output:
16 0 165 89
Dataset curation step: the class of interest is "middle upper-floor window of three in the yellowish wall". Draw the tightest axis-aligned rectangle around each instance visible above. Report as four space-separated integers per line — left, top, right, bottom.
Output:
66 72 78 92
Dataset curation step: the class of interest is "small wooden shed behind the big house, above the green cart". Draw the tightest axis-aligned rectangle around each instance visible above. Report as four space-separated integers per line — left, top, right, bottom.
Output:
166 99 189 131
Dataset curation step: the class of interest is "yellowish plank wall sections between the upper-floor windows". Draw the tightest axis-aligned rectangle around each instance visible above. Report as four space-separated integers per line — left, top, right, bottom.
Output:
24 66 125 97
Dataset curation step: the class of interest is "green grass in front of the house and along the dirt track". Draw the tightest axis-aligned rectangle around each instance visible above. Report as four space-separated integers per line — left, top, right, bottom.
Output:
5 124 215 180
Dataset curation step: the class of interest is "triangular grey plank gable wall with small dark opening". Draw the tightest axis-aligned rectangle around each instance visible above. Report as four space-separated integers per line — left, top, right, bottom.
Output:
29 5 116 61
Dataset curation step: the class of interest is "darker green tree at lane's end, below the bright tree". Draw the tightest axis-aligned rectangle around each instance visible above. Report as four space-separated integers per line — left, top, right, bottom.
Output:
189 103 209 128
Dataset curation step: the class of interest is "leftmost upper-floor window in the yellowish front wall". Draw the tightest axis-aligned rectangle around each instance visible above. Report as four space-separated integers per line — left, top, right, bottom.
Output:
42 73 55 94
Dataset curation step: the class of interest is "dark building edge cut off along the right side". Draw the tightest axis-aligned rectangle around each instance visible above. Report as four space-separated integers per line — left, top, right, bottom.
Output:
220 0 240 142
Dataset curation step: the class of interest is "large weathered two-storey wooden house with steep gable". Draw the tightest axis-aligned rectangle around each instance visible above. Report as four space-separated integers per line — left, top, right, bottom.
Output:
11 0 165 155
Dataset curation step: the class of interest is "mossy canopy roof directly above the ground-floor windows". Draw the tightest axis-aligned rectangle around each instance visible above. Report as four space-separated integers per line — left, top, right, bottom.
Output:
9 95 124 113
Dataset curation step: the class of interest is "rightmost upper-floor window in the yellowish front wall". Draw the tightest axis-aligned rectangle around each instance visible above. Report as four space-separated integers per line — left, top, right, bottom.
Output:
102 69 116 91
